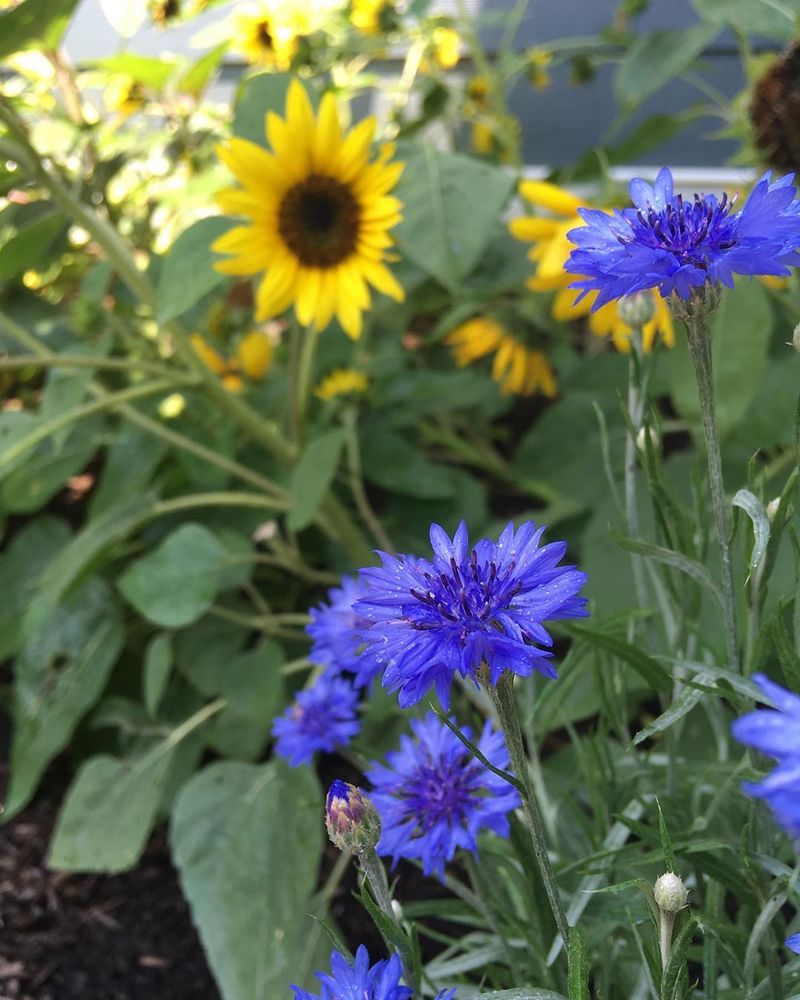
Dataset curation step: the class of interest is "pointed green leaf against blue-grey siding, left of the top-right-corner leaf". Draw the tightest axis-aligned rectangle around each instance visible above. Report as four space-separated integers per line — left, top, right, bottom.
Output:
614 24 720 105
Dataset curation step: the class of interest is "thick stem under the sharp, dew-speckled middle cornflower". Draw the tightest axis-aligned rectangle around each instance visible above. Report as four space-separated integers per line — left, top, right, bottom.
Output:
489 671 569 947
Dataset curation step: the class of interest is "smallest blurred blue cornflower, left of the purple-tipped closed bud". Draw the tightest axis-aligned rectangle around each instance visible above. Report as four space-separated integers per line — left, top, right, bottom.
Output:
272 674 360 767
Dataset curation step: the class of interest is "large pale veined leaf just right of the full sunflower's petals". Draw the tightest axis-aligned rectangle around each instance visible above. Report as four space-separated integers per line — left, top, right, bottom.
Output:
394 144 514 292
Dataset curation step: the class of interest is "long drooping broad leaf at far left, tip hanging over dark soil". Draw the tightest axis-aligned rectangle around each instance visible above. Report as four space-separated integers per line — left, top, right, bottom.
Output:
6 579 123 818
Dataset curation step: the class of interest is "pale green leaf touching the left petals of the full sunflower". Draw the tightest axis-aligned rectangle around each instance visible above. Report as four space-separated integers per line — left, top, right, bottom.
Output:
156 216 233 323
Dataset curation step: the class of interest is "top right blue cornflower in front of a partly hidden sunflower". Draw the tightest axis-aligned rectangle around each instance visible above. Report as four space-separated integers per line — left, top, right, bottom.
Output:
565 168 800 309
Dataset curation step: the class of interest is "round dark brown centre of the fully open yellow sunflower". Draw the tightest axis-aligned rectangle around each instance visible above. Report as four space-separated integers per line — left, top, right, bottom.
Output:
278 174 360 267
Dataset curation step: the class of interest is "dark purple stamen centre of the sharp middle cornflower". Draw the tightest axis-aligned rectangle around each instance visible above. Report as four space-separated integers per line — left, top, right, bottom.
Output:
405 549 522 629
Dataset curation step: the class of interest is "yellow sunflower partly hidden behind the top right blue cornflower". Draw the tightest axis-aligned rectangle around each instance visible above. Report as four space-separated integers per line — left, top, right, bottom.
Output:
509 181 675 351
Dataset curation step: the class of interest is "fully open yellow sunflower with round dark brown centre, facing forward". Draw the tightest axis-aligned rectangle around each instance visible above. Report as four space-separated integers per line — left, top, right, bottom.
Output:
212 80 404 339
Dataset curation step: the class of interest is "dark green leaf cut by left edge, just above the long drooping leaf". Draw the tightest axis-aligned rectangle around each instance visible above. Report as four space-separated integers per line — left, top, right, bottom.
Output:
0 514 70 660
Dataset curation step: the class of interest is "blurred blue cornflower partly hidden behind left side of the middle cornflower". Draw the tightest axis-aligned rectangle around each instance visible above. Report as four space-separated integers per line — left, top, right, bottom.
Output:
306 576 381 687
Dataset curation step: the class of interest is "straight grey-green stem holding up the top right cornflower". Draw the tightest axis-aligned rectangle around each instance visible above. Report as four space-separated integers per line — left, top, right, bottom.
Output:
686 309 739 669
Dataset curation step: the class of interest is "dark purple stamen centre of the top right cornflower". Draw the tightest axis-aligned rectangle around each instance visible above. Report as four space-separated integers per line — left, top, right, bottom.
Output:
632 194 736 268
